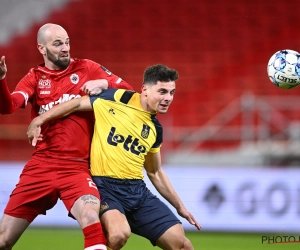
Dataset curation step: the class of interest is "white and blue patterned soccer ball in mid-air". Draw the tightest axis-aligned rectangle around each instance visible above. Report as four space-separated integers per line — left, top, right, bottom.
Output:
268 49 300 89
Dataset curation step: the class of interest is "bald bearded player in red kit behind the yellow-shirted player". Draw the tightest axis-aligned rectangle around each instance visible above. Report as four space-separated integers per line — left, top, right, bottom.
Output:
0 23 132 250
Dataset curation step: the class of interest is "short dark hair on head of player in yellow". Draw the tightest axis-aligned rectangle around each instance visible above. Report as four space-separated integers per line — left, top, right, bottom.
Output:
143 64 178 85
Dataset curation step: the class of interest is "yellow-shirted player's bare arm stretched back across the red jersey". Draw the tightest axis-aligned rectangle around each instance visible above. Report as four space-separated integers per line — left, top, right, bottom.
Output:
27 96 93 146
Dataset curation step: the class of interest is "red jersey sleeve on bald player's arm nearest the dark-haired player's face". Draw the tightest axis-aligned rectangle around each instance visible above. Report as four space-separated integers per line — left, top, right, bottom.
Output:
86 59 133 90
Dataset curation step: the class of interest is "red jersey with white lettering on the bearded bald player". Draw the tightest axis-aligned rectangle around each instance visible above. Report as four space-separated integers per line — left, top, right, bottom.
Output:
12 59 131 161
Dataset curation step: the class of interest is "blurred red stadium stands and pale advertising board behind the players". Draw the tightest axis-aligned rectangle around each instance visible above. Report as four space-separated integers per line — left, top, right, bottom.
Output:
0 0 300 248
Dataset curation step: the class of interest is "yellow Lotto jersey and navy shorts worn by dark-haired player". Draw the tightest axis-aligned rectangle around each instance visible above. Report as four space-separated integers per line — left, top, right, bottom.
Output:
90 89 181 246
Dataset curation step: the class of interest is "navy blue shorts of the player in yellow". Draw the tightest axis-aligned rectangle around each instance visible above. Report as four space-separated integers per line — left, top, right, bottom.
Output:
92 176 181 246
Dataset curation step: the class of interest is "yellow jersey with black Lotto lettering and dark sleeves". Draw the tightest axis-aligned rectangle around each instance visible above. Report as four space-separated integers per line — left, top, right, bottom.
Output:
90 89 163 179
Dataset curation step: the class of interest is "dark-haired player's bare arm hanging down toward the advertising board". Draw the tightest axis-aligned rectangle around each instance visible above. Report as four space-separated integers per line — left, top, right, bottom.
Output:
144 152 201 230
